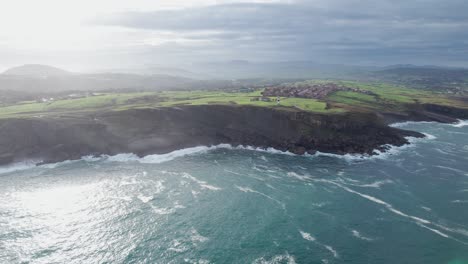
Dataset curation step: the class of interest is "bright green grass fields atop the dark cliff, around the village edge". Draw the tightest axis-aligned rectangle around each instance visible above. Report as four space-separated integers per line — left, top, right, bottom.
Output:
0 80 467 118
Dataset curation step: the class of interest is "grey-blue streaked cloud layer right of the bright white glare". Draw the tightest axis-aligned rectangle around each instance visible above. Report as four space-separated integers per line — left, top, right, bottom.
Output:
94 0 468 64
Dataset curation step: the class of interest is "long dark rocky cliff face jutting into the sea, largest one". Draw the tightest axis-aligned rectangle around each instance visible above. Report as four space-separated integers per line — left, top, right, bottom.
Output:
0 105 422 164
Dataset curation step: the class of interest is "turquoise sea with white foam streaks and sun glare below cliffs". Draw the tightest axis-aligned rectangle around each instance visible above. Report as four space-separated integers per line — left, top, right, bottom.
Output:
0 120 468 264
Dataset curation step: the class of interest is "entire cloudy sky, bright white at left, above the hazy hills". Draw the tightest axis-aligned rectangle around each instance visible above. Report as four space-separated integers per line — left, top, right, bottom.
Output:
0 0 468 71
